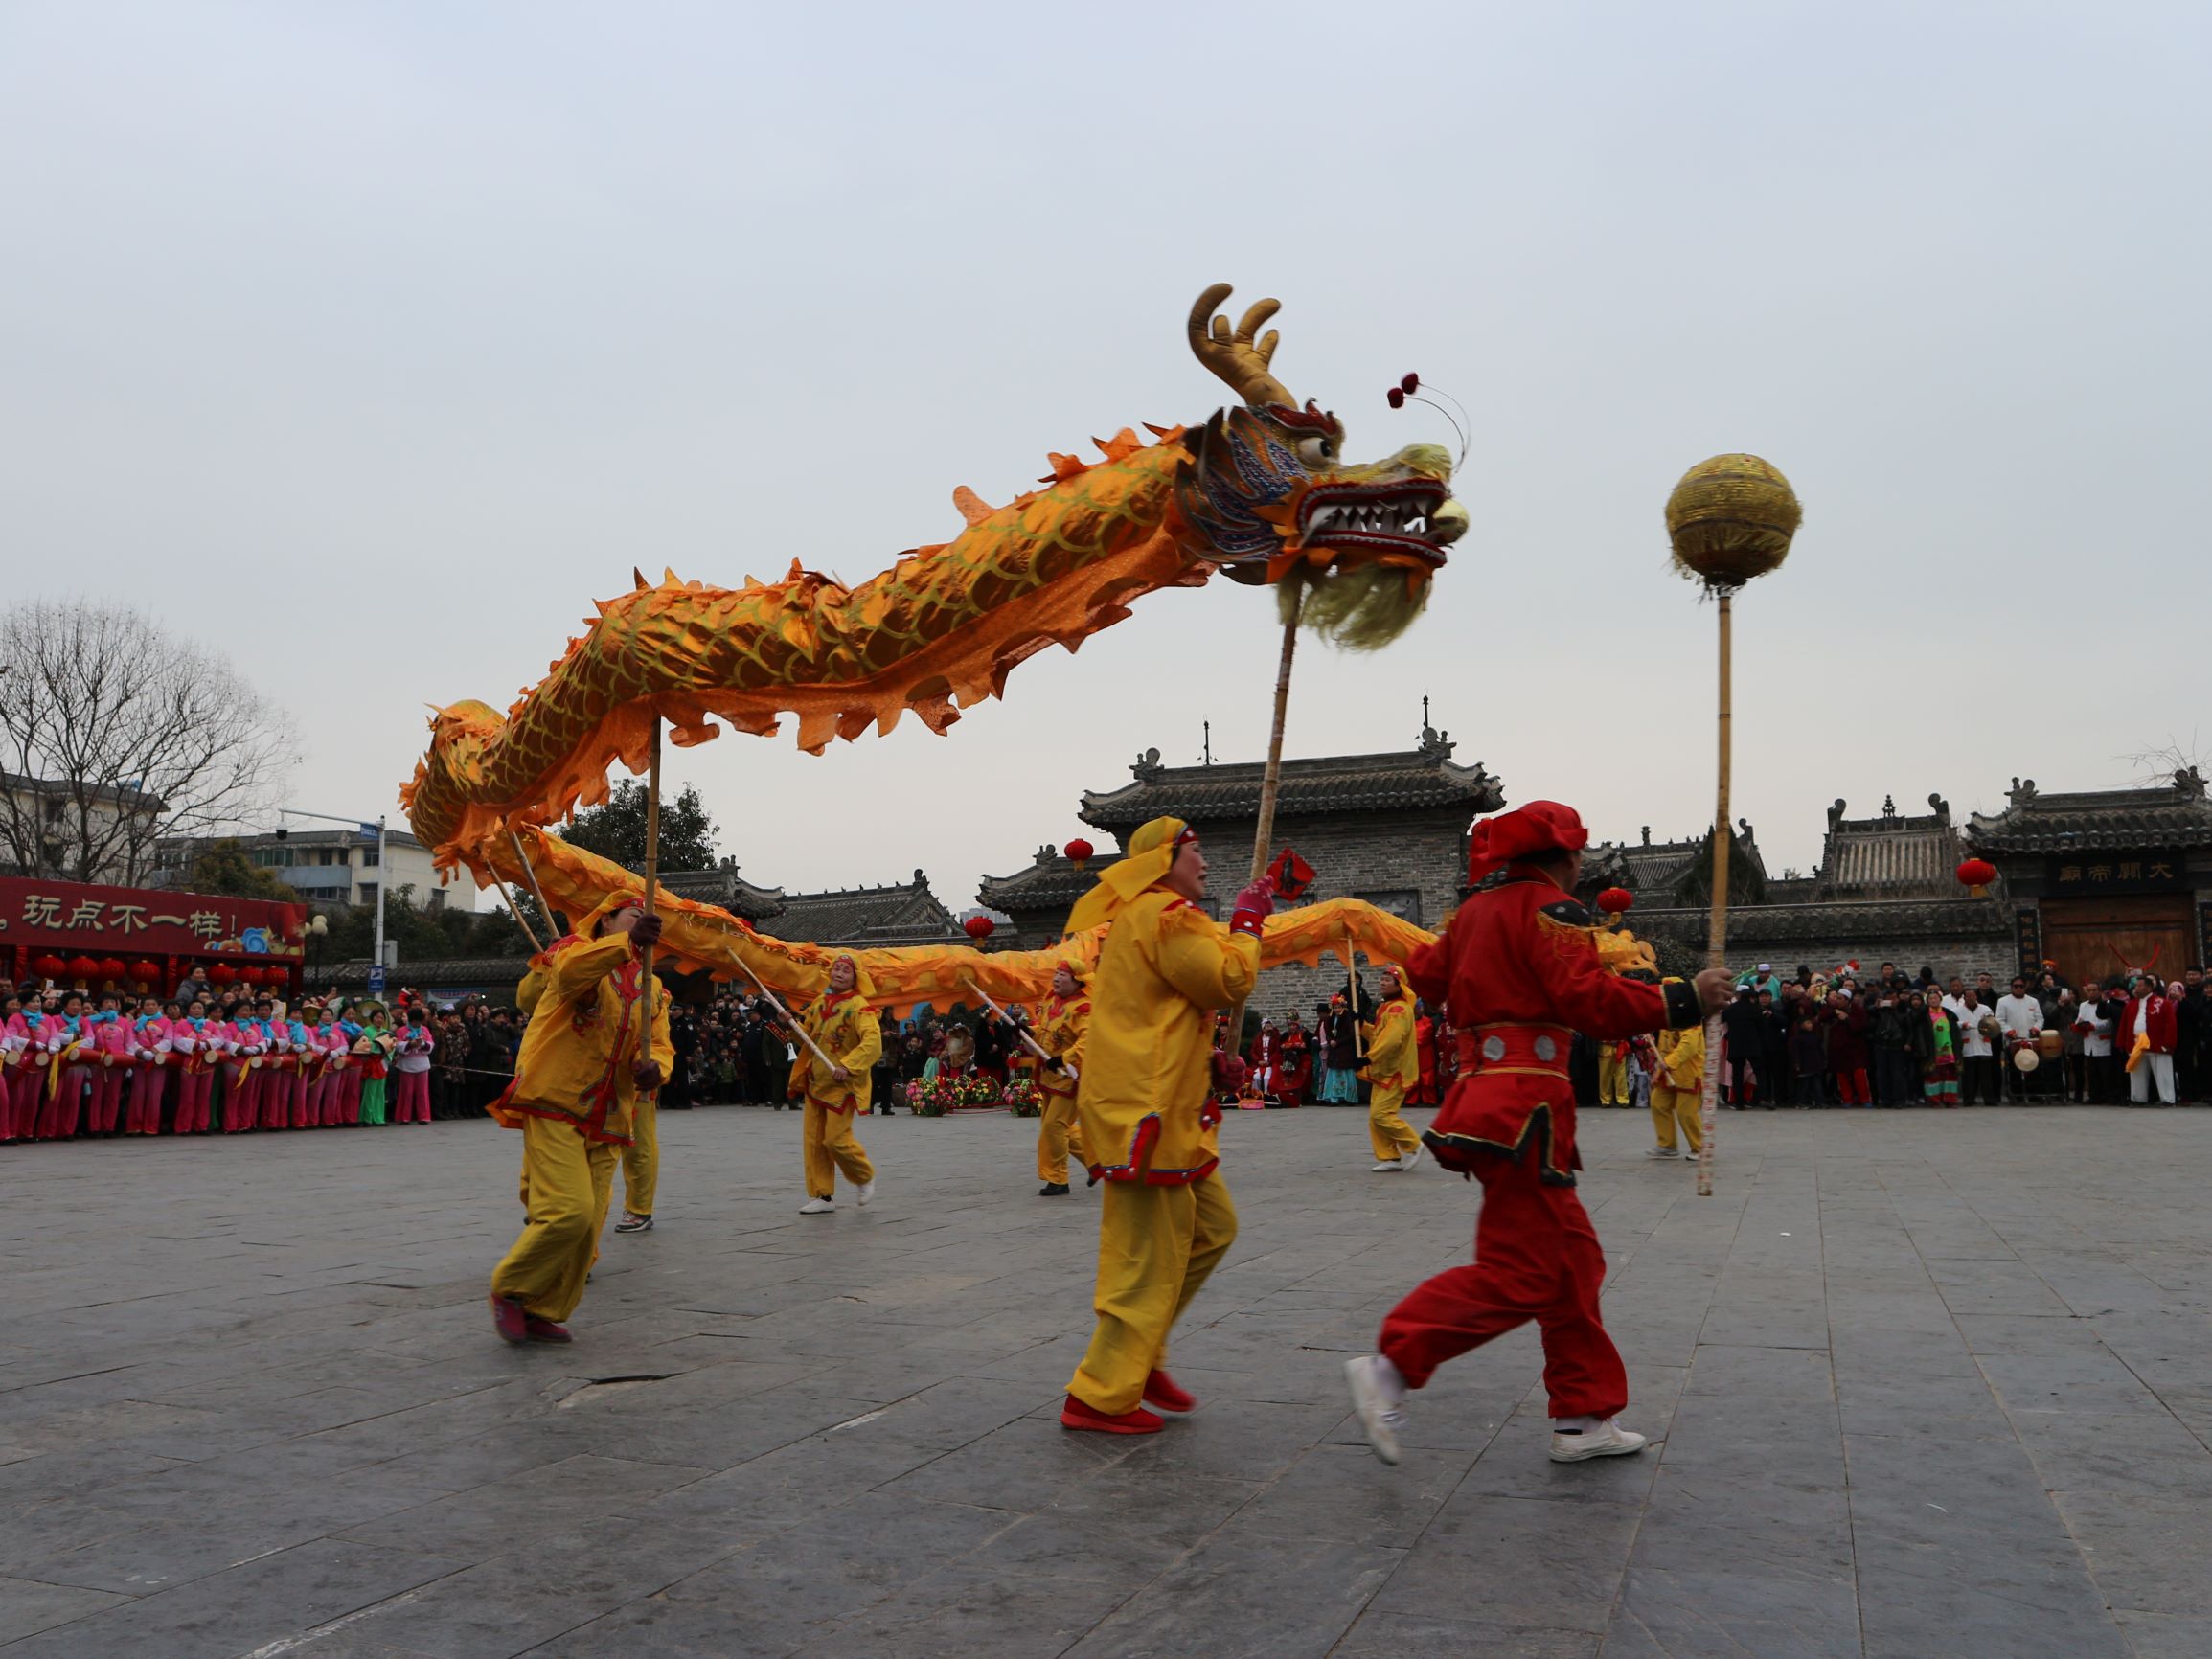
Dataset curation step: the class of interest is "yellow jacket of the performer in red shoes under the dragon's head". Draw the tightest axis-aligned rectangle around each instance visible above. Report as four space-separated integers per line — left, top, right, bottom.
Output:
1075 887 1259 1186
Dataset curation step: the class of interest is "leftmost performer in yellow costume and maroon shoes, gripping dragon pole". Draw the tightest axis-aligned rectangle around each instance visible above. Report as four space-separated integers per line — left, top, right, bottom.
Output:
491 894 674 1343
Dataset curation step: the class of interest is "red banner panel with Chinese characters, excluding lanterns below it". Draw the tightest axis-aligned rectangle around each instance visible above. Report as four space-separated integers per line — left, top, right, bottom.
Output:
0 875 308 963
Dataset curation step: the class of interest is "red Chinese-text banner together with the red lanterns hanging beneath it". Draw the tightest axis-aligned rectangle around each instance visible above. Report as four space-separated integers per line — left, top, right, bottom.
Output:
0 875 308 995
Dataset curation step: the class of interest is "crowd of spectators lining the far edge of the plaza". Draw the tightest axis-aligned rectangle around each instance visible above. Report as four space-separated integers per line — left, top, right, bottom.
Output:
12 963 2212 1142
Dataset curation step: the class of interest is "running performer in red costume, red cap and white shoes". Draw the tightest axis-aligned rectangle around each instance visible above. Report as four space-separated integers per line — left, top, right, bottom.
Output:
1345 801 1732 1465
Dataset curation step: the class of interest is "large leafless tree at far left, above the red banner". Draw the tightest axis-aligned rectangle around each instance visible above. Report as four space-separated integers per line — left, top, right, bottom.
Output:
0 600 296 885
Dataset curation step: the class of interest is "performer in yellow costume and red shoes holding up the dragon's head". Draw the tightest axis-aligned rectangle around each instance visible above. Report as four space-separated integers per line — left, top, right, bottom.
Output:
1060 818 1274 1433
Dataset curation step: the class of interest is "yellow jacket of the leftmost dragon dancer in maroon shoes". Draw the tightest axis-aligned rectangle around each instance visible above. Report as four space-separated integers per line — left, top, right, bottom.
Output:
491 916 674 1146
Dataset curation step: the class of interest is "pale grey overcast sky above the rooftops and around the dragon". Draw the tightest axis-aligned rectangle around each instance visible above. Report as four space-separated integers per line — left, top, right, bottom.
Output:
0 0 2212 907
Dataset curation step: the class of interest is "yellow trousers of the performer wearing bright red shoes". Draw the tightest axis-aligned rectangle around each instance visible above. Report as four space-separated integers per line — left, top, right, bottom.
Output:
1068 1170 1237 1416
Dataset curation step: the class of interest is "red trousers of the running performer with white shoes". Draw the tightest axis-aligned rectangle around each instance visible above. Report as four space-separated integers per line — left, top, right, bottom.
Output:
1379 1159 1628 1418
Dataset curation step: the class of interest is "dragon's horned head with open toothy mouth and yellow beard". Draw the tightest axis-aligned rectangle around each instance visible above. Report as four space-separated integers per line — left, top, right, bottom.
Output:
1174 284 1467 626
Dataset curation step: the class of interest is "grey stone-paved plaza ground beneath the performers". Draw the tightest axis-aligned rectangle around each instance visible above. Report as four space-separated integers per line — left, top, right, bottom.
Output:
0 1108 2212 1659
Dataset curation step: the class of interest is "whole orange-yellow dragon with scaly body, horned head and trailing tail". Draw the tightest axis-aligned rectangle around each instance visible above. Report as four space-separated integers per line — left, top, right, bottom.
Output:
400 284 1467 1009
